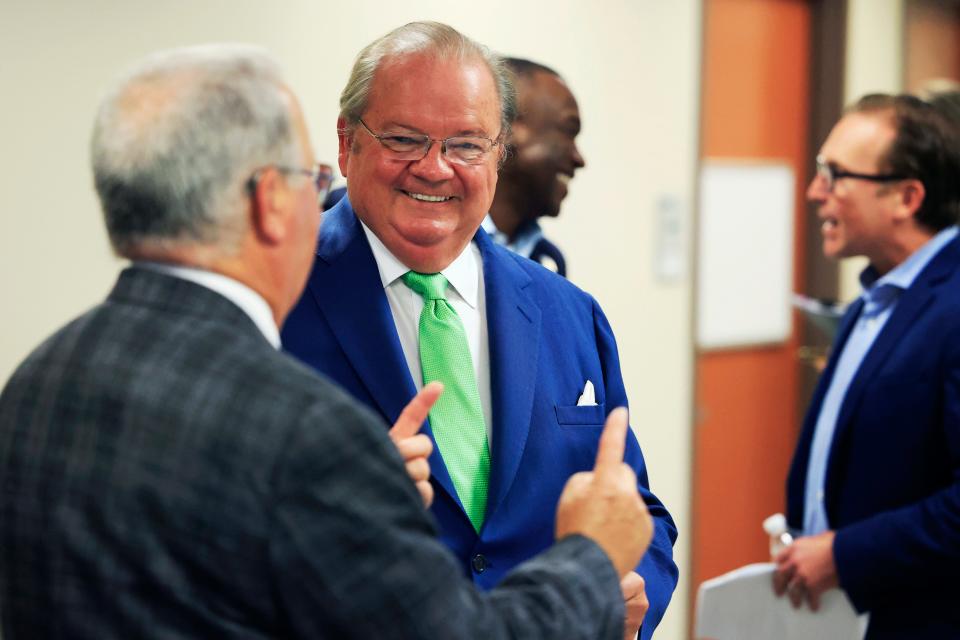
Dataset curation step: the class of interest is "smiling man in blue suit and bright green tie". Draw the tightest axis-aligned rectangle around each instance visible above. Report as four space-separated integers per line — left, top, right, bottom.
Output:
283 23 677 638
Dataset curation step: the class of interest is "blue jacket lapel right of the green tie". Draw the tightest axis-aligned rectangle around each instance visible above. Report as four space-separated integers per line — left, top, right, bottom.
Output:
474 230 541 520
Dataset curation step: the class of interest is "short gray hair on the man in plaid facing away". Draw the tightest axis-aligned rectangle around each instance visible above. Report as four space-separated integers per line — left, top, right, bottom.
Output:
90 45 303 257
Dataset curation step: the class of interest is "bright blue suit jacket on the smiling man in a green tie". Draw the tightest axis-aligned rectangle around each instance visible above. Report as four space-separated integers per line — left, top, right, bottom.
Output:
282 198 677 638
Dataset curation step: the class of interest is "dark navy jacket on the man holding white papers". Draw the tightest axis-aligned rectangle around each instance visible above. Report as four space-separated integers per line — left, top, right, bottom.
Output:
787 232 960 638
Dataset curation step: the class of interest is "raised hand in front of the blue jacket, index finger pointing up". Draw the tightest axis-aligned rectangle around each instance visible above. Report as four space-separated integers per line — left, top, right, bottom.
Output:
557 407 653 578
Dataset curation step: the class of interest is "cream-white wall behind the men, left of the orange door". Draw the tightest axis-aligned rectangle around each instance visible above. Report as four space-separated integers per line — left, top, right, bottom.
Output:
0 0 702 639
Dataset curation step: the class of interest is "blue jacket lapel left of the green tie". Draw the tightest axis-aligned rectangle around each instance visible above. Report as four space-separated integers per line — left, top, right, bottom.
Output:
308 198 466 502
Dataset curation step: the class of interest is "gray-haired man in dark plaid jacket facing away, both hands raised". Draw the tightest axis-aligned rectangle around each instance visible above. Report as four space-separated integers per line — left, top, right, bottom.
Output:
0 47 651 640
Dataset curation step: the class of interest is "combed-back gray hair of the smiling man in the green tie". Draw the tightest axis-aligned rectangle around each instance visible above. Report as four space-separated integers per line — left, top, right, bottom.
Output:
340 22 517 137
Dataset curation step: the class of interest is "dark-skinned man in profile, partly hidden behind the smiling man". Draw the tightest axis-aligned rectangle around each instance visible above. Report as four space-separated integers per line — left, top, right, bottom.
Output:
483 58 585 277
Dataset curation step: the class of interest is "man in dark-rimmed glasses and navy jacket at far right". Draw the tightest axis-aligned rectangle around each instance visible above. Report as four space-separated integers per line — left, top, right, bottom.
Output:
774 95 960 639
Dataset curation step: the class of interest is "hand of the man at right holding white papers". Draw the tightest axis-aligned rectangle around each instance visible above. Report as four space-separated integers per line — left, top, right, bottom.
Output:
773 531 840 611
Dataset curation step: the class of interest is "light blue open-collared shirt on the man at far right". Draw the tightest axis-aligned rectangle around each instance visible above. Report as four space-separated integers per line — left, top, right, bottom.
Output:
803 227 958 535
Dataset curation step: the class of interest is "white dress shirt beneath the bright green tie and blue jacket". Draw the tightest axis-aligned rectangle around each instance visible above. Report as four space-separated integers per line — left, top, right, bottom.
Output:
360 222 493 446
